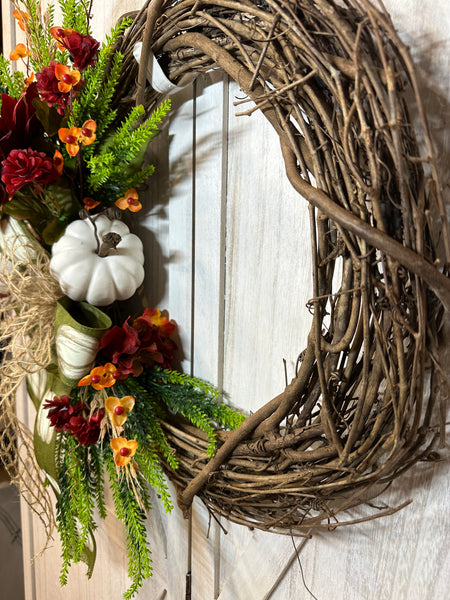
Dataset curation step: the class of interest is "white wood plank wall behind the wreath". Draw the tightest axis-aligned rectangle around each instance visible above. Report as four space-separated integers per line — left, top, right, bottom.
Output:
2 0 450 600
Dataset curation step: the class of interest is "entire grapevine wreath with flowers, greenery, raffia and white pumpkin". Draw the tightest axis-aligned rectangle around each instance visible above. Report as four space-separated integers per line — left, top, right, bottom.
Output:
0 0 450 597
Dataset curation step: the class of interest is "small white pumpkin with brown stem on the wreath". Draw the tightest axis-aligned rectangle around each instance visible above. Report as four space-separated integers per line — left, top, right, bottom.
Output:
50 214 144 306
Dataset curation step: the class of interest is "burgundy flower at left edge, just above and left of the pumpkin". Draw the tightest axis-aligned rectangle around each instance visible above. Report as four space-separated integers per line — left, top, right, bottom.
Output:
1 148 59 194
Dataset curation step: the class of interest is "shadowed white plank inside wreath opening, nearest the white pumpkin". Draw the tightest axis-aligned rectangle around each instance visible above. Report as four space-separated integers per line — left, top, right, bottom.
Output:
137 86 194 373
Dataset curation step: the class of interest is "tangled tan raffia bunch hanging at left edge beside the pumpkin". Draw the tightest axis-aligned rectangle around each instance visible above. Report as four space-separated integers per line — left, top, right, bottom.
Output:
0 219 61 539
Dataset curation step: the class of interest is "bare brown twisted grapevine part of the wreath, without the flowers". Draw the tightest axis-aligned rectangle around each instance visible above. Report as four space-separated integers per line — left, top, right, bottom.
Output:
111 0 450 533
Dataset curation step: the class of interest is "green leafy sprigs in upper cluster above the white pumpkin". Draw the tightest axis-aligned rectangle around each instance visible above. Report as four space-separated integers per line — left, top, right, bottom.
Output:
0 0 170 240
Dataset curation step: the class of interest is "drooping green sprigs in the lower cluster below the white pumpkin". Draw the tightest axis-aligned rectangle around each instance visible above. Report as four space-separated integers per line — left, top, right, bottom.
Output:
57 367 244 600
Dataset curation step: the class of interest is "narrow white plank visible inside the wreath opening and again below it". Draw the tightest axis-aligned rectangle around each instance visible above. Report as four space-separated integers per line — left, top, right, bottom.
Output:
191 72 227 599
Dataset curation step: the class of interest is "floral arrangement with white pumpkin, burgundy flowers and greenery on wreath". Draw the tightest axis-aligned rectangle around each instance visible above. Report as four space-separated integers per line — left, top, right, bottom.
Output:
0 0 243 598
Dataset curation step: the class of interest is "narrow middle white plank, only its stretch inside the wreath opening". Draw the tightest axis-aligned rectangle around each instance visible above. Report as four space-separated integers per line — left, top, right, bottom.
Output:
193 71 228 385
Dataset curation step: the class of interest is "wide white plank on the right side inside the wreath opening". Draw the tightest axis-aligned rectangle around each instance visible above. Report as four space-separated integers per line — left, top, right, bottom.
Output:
224 85 312 418
